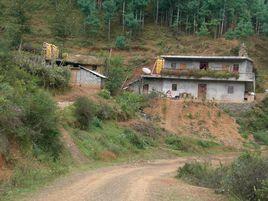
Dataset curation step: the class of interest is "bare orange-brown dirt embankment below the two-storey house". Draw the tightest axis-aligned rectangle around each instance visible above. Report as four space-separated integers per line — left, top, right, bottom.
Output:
145 99 243 147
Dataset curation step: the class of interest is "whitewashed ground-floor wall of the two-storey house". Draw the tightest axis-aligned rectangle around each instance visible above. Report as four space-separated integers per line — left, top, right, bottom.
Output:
130 79 245 102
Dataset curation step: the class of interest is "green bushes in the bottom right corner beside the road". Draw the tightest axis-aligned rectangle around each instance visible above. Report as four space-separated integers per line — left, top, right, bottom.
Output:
178 153 268 201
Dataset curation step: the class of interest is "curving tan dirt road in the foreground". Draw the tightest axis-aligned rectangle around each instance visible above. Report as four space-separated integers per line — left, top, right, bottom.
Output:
23 155 234 201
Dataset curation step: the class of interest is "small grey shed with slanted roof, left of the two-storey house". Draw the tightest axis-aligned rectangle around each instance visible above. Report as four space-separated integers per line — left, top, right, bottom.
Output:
71 66 107 88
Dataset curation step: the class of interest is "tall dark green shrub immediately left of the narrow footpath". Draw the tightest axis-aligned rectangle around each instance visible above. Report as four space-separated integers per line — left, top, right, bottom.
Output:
23 90 61 157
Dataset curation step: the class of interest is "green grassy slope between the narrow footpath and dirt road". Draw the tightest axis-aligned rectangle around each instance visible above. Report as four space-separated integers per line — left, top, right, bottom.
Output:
68 122 153 160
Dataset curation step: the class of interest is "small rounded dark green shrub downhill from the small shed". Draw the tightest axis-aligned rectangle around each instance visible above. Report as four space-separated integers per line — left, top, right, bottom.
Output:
74 97 97 129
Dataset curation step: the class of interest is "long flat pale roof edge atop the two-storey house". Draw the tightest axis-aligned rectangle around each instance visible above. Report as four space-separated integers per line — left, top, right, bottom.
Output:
161 55 253 62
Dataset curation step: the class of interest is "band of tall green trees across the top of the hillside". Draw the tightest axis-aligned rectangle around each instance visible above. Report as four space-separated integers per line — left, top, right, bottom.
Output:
0 0 268 49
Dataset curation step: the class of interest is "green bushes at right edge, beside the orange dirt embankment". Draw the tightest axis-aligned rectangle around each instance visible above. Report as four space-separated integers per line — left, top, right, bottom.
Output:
237 97 268 145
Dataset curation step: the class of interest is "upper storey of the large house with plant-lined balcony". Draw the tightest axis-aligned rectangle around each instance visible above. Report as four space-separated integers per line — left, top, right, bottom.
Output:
159 55 255 81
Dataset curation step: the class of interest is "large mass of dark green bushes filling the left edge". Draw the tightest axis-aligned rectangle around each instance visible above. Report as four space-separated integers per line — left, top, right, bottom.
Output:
0 84 61 158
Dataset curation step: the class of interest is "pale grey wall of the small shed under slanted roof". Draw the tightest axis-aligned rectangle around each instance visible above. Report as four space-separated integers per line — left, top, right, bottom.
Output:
76 69 103 87
